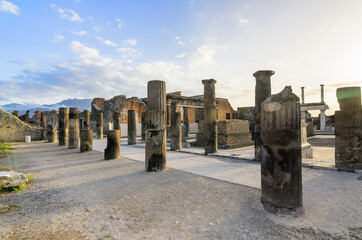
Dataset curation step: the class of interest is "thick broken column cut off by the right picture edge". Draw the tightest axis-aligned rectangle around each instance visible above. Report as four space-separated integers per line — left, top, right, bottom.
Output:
335 87 362 171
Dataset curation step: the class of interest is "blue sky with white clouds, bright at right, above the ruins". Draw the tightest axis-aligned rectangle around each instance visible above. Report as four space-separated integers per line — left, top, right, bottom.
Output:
0 0 362 114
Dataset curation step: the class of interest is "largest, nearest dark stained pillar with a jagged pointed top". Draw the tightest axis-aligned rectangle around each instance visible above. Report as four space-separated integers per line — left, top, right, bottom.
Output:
260 86 303 214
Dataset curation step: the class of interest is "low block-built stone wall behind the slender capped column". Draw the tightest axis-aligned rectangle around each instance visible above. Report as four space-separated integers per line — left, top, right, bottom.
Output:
192 119 254 149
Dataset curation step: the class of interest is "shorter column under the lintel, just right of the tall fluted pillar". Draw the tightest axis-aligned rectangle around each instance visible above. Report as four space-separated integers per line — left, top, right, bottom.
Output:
171 102 182 151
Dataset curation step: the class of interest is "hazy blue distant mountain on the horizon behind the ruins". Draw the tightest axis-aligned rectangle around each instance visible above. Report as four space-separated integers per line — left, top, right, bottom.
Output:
0 98 93 116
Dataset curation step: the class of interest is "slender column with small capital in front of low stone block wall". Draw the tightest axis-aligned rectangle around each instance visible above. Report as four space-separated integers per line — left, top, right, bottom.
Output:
202 79 217 155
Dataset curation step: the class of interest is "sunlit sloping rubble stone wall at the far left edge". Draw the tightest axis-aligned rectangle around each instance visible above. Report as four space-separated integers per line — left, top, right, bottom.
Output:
0 109 43 142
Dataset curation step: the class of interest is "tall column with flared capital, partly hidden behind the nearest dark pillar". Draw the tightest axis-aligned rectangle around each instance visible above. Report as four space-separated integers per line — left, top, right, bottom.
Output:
253 70 274 161
